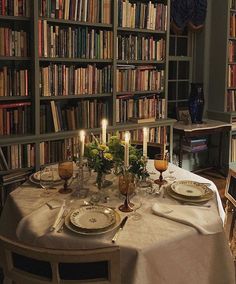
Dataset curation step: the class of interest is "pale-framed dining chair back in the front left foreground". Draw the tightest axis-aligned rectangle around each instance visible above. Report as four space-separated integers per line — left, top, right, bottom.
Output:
0 236 121 284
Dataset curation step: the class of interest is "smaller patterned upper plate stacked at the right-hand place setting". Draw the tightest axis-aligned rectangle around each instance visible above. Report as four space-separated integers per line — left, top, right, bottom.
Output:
171 180 212 199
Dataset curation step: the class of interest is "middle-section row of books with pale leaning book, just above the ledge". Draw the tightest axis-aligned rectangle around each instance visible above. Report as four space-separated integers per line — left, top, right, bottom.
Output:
40 99 109 133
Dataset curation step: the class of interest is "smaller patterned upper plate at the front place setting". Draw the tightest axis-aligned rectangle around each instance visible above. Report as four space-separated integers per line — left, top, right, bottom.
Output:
70 205 116 230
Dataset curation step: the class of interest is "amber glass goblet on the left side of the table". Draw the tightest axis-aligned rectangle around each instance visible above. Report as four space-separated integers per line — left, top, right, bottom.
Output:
58 160 73 194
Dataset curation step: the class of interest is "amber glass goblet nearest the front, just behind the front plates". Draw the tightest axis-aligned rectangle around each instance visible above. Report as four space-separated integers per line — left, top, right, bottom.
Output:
119 172 135 212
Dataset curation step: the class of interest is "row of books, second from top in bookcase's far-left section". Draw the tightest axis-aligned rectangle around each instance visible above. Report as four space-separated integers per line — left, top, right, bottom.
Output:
0 27 29 57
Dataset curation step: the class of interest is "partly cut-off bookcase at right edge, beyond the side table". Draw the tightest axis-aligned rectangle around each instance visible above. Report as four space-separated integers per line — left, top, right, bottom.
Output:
208 0 236 165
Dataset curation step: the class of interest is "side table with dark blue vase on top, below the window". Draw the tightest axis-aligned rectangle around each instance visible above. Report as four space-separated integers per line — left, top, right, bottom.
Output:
173 120 231 171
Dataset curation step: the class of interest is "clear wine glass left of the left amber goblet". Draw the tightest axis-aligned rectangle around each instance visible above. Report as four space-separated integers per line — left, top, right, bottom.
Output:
39 166 54 196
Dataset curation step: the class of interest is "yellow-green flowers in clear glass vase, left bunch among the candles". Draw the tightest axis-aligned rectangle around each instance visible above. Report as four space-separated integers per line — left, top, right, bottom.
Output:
85 137 114 188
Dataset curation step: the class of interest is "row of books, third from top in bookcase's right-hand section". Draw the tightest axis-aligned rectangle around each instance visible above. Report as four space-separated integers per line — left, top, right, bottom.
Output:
116 66 165 92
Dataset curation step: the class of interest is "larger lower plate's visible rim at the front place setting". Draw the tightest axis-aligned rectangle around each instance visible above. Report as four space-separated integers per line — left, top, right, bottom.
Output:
65 211 121 236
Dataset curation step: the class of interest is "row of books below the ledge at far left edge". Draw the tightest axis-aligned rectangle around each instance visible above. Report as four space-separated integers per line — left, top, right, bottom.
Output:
0 144 35 171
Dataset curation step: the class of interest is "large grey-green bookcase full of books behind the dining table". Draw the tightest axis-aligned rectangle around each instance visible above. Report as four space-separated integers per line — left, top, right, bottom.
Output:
0 0 175 173
